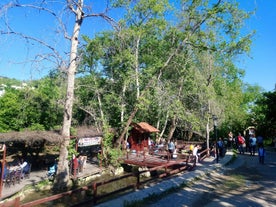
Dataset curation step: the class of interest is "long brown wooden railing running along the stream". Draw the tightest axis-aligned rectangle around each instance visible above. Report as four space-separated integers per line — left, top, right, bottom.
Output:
0 149 209 207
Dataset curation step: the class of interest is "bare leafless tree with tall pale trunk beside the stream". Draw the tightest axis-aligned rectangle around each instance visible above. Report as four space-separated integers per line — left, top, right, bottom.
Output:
0 0 116 188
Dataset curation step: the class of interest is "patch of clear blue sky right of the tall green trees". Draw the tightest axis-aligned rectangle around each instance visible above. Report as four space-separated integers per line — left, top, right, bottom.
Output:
240 0 276 91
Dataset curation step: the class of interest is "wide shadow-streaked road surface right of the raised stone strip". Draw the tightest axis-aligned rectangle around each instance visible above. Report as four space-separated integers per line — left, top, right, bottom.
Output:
147 149 276 207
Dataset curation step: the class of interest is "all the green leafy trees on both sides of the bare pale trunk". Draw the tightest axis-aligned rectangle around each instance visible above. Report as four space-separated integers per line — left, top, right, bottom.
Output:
0 0 262 155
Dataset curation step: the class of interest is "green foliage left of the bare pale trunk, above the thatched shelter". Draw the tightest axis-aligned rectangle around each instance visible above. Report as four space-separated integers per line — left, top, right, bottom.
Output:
0 73 63 132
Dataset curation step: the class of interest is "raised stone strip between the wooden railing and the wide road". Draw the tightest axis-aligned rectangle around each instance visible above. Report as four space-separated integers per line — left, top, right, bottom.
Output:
96 152 233 207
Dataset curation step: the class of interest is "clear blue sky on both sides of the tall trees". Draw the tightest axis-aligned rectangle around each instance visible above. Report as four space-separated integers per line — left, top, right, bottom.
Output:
0 0 276 91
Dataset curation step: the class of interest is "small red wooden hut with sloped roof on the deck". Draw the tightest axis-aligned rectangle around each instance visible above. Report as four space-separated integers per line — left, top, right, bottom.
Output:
128 122 159 152
